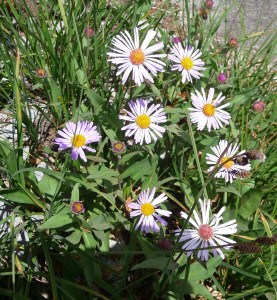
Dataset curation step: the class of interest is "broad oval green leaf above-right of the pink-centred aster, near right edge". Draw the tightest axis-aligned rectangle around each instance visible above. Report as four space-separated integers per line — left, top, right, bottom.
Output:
238 189 262 218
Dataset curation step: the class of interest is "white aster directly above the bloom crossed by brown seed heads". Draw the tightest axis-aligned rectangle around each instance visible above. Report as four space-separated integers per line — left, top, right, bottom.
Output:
189 88 231 132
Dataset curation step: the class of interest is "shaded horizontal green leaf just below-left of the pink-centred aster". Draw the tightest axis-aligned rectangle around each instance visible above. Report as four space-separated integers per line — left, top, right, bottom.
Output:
131 257 178 271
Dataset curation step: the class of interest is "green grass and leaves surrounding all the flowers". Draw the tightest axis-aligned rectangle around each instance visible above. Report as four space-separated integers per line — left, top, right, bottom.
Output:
0 0 277 300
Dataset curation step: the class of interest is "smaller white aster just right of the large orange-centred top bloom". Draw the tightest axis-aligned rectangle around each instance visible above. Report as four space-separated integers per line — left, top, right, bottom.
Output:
168 43 206 83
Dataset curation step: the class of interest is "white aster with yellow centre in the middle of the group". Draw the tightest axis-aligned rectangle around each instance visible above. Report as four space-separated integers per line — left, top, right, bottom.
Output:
119 99 166 145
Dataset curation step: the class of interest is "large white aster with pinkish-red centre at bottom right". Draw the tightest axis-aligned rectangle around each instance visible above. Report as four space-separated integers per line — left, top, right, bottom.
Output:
175 199 237 261
